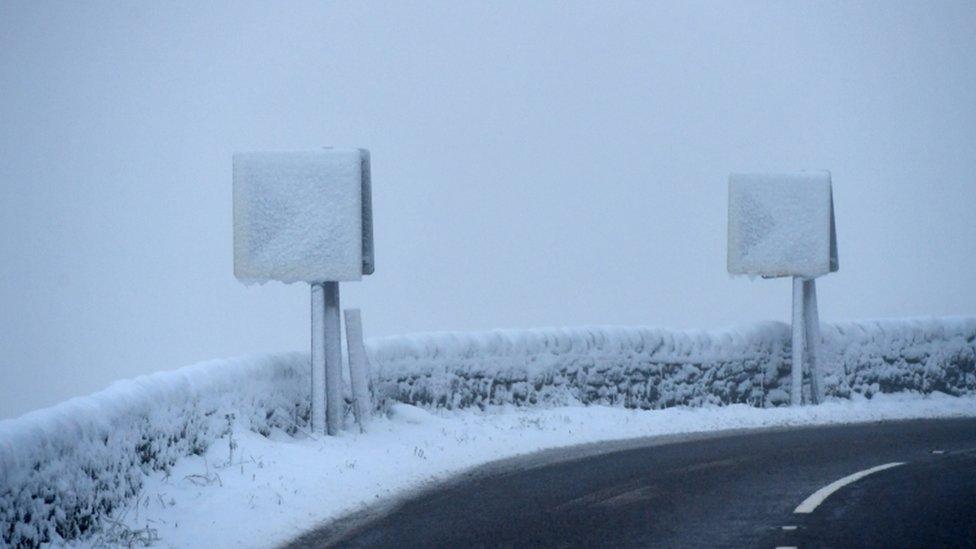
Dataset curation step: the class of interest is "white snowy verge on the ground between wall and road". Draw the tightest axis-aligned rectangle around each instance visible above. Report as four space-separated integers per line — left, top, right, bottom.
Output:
101 393 976 548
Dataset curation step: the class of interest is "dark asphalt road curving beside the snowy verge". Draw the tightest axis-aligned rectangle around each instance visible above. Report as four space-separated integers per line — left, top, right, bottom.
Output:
292 419 976 548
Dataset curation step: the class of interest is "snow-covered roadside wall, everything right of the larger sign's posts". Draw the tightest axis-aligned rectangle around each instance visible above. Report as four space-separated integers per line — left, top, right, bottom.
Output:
370 318 976 409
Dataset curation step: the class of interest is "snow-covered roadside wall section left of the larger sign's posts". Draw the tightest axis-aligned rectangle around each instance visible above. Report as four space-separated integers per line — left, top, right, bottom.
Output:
0 354 309 547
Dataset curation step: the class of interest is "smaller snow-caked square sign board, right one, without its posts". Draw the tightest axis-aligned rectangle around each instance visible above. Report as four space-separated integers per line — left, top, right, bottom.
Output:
728 171 838 278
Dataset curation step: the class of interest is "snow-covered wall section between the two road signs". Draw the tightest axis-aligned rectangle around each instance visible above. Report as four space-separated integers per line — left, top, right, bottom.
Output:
370 323 789 408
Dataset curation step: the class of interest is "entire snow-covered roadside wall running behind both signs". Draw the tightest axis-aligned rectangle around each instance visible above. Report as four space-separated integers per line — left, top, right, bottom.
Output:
0 318 976 547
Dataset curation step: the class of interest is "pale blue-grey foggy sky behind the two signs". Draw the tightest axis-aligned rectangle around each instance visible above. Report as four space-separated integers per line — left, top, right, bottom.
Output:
0 1 976 417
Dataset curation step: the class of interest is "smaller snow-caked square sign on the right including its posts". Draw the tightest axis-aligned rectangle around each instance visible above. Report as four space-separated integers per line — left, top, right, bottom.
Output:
728 171 839 406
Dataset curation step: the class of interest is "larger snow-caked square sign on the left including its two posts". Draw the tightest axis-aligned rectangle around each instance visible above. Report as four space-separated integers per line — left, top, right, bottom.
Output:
234 148 374 435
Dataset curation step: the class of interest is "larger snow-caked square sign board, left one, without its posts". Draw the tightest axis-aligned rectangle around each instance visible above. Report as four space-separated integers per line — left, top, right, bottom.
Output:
234 149 373 282
